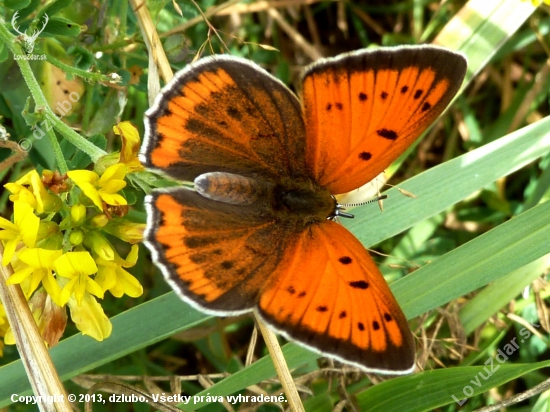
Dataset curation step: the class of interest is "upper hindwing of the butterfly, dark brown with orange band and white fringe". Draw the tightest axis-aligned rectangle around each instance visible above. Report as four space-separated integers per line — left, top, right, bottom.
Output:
141 56 306 181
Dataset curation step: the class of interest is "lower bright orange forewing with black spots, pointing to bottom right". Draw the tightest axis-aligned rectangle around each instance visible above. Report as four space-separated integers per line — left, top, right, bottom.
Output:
259 221 415 373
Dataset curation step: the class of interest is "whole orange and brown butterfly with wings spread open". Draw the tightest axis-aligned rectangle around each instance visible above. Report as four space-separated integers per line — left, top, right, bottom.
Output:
140 46 466 374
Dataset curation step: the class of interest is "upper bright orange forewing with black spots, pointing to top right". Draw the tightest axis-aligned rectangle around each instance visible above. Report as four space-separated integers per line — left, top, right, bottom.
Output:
302 46 466 194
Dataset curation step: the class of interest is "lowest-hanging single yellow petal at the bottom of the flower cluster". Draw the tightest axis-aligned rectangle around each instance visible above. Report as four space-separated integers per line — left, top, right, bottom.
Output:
68 293 113 342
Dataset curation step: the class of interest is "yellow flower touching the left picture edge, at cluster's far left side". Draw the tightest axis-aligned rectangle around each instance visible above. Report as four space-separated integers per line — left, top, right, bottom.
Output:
0 201 40 266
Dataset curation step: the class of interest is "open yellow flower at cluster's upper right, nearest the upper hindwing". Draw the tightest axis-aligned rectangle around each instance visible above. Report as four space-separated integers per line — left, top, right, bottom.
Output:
67 163 128 210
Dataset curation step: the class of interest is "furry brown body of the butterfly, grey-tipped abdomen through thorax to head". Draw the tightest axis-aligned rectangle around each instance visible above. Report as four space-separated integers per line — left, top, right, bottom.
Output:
195 172 336 225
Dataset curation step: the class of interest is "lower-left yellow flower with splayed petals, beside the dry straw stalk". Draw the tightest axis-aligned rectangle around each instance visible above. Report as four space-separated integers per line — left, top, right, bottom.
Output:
7 248 63 306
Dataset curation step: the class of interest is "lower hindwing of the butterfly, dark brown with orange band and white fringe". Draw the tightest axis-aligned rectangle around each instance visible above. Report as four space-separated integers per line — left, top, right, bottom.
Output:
145 188 300 315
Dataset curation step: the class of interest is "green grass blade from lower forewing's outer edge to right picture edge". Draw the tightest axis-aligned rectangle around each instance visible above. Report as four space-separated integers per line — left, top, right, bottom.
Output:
392 202 550 318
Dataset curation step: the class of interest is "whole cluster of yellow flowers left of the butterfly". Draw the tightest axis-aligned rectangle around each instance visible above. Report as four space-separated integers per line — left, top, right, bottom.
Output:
0 122 144 353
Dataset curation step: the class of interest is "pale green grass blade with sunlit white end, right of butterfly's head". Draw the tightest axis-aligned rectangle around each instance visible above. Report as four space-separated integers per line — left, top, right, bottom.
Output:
343 117 550 246
